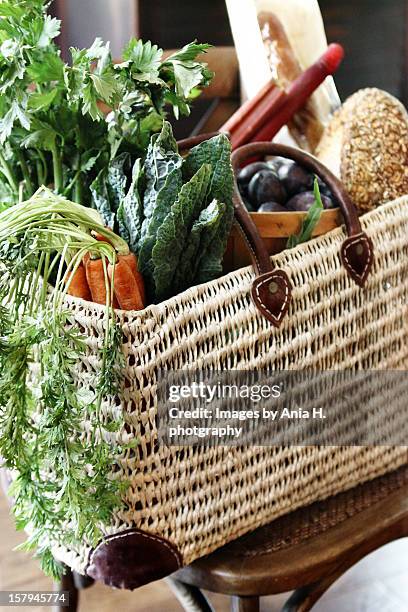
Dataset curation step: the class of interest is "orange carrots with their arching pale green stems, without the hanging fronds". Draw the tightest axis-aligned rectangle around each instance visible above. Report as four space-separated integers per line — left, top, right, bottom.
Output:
0 187 146 310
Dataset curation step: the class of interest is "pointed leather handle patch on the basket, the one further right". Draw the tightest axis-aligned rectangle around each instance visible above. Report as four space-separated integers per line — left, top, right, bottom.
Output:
341 232 374 287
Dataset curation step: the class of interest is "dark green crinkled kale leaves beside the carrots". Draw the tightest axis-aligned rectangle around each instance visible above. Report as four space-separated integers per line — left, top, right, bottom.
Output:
93 122 233 302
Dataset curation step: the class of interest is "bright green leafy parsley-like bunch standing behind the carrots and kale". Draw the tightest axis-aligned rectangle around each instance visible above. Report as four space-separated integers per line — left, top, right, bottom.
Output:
0 0 212 209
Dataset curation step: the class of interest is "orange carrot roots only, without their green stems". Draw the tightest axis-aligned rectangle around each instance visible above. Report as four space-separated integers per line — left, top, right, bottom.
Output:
68 232 146 310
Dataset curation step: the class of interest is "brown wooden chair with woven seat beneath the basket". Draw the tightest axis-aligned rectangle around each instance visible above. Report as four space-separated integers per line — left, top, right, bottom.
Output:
60 467 408 612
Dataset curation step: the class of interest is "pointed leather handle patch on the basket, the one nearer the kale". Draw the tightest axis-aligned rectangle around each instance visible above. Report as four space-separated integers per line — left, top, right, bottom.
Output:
251 270 292 327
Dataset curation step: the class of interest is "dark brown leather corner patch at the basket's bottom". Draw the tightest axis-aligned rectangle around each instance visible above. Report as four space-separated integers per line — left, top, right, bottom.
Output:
86 529 182 590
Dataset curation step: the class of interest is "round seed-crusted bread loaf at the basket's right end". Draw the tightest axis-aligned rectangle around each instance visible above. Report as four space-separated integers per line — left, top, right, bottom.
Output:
316 88 408 212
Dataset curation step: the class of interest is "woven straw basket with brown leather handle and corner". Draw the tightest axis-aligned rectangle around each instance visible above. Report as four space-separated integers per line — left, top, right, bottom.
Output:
22 144 408 588
